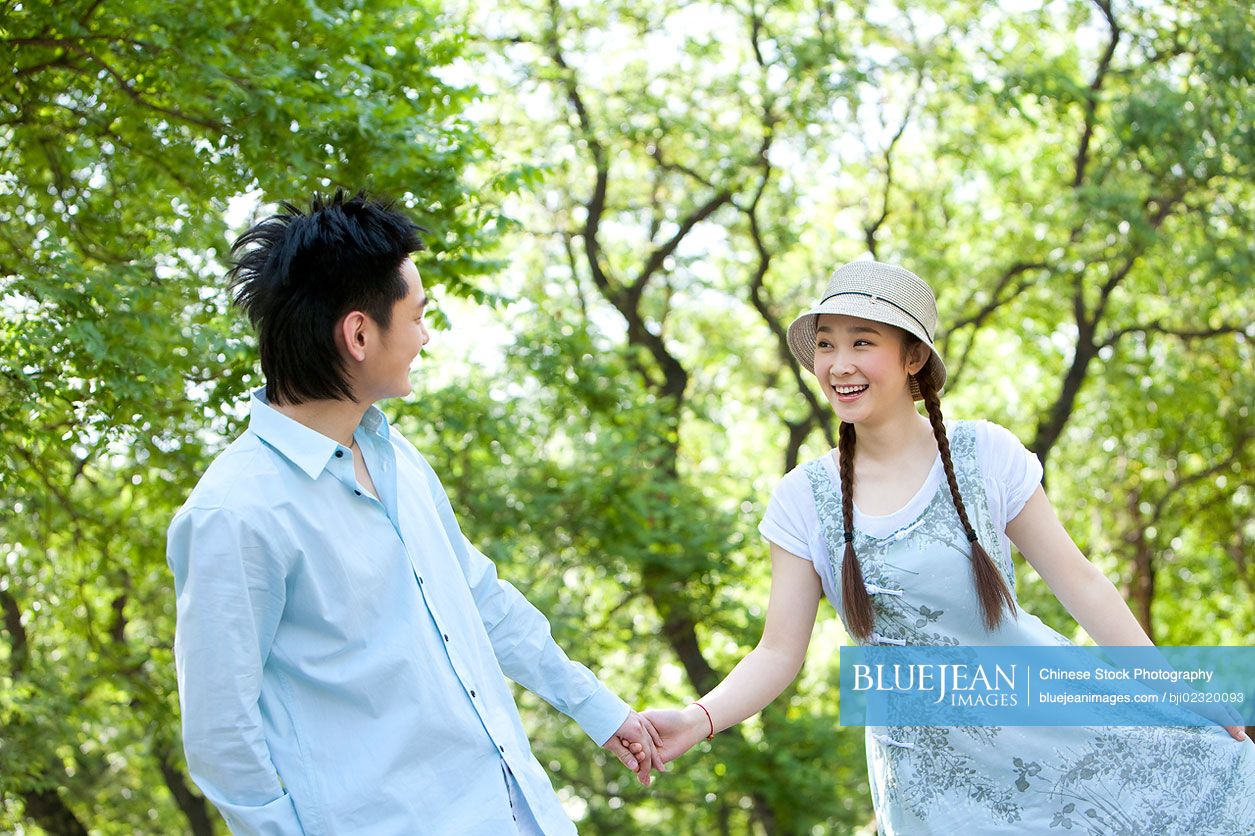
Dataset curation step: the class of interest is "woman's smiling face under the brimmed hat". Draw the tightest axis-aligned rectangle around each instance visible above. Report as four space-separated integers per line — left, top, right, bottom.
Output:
814 314 927 423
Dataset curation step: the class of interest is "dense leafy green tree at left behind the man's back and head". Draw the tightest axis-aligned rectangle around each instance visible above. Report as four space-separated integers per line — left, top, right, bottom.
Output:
0 0 499 833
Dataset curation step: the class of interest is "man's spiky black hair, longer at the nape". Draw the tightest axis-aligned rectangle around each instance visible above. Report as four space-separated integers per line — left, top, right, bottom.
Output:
227 190 427 404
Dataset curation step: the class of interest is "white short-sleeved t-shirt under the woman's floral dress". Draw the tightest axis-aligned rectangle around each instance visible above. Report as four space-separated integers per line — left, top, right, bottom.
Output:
758 421 1042 575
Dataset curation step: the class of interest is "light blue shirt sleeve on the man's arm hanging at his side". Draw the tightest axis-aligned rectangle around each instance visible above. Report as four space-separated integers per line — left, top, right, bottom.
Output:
167 508 304 835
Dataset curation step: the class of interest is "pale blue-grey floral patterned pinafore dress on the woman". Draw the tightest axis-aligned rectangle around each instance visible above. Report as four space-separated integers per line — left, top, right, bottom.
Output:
804 422 1255 836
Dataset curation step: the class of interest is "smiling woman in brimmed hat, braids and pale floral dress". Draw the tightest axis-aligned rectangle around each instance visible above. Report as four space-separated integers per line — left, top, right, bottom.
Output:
645 261 1255 836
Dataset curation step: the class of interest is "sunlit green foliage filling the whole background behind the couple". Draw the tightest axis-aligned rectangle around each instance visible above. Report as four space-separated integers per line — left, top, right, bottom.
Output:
0 0 1255 833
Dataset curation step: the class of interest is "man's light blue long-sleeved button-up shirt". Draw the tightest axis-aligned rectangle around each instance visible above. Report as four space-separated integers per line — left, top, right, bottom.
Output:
168 389 629 836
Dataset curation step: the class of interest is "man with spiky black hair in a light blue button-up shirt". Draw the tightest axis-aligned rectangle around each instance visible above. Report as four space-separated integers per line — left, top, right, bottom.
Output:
168 192 661 836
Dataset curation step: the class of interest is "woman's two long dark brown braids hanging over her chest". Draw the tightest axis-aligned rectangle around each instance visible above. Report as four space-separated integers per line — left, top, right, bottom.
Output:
837 331 1015 641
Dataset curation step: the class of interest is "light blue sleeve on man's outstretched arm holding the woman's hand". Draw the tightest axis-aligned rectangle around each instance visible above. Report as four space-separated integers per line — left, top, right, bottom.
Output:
424 461 631 746
